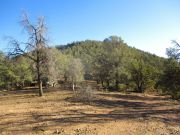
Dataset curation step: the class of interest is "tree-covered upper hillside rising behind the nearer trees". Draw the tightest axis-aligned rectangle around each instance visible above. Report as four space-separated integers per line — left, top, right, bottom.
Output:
56 36 167 75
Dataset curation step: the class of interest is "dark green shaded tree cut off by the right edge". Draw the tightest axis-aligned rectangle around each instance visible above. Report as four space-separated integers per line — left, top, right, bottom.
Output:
161 41 180 98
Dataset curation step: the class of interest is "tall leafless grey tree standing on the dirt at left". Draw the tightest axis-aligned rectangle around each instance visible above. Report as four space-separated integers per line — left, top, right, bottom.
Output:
9 14 47 96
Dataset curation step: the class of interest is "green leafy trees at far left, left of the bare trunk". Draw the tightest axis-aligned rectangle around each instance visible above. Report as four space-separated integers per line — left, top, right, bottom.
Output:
0 53 33 89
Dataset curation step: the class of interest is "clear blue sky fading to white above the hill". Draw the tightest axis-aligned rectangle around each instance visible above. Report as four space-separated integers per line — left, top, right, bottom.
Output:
0 0 180 57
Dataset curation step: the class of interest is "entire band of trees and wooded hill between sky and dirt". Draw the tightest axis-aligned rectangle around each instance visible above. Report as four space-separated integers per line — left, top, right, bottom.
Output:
0 15 180 98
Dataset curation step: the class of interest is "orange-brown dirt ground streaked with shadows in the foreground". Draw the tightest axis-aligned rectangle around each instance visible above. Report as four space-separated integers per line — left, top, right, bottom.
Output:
0 88 180 135
